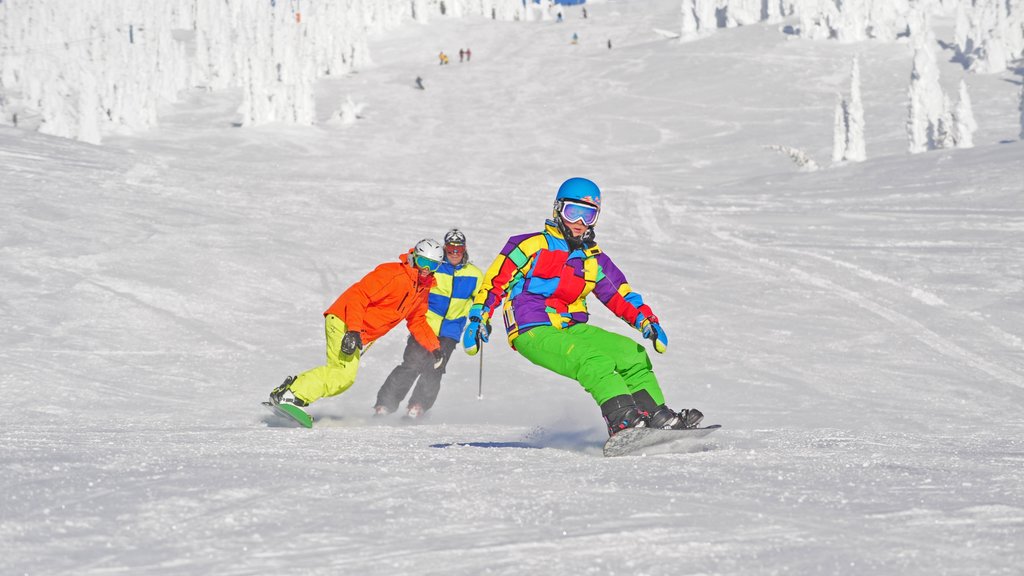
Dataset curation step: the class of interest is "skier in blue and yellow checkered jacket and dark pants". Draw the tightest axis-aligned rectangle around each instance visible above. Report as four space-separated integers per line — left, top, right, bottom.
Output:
374 229 483 418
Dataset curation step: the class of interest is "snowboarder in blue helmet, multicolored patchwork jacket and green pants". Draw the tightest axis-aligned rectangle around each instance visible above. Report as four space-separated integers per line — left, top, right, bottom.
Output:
462 178 703 436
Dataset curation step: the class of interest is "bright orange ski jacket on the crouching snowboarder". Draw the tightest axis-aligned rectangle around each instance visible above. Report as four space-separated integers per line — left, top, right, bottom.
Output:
324 250 440 352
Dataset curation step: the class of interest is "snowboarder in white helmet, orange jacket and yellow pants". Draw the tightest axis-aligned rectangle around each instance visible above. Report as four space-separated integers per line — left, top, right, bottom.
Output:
270 239 444 408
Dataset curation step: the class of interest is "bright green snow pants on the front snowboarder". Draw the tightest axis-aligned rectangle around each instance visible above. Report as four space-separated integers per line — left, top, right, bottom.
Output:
513 324 665 406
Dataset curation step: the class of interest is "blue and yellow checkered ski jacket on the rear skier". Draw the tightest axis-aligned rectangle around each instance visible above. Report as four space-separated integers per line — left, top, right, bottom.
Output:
427 260 483 340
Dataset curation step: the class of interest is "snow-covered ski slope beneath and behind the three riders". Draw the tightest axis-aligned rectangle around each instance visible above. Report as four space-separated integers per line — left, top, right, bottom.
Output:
0 1 1024 575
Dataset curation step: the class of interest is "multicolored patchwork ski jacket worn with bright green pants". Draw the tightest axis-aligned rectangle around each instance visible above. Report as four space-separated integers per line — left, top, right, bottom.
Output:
470 220 654 347
